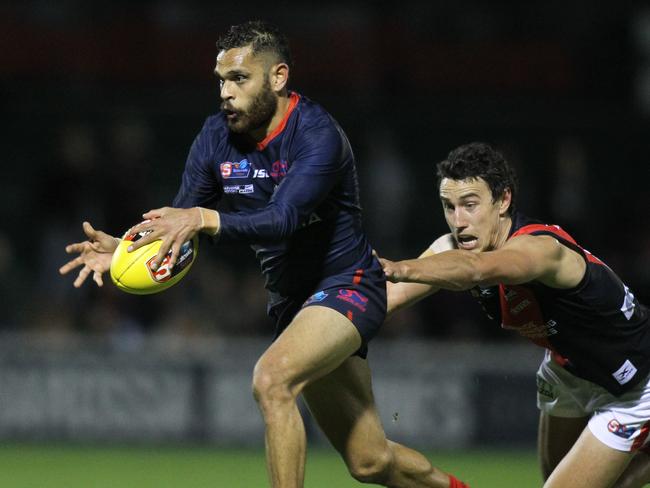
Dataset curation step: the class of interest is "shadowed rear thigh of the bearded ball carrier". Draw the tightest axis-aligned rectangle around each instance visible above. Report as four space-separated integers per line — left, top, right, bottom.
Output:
303 356 388 465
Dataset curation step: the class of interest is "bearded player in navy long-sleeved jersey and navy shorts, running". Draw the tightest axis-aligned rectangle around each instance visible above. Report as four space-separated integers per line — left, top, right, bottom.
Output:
61 22 465 488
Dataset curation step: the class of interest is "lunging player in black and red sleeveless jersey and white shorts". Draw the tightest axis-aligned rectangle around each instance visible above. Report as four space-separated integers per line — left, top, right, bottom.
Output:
382 143 650 488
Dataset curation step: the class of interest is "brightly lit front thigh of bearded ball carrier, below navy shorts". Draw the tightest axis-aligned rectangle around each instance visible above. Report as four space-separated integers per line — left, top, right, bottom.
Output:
253 306 361 393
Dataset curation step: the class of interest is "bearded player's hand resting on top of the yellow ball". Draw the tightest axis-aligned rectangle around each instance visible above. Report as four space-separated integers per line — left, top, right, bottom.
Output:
128 207 202 269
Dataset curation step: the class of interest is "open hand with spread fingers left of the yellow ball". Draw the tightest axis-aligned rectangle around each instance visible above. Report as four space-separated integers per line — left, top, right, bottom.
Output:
59 222 119 288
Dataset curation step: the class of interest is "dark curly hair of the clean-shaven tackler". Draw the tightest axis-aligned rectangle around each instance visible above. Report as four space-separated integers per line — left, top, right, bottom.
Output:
437 142 517 214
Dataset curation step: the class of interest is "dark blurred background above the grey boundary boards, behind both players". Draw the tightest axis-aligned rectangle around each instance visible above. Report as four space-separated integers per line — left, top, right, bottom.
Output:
0 0 650 349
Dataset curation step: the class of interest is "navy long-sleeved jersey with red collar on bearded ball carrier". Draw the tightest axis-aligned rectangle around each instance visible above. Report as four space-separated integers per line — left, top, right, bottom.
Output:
173 93 373 307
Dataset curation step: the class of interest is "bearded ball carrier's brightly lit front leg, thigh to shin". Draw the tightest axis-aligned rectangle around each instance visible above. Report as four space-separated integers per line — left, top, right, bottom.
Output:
253 306 361 488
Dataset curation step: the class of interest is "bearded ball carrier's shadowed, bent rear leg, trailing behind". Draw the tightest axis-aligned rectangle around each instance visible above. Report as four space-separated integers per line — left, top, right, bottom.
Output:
303 350 449 488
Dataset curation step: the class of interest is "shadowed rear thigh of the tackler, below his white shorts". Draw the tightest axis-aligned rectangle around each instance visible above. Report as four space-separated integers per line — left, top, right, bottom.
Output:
537 412 589 479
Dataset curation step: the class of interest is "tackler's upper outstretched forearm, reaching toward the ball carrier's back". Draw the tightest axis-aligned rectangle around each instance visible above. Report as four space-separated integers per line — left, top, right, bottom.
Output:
391 250 483 291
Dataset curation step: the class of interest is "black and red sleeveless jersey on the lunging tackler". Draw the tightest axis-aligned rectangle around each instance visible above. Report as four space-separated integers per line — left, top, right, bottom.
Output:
472 213 650 395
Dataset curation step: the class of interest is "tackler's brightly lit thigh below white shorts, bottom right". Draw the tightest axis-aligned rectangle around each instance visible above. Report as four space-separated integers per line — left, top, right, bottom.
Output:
544 429 632 488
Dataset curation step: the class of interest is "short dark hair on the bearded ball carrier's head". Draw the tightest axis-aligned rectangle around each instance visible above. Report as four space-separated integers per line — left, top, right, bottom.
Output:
217 20 293 67
